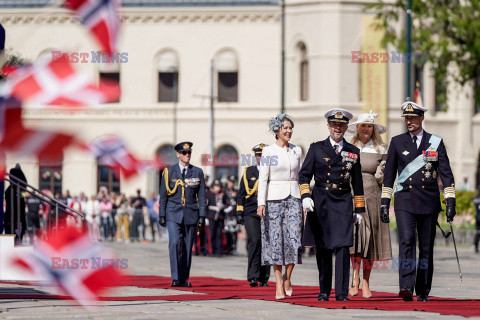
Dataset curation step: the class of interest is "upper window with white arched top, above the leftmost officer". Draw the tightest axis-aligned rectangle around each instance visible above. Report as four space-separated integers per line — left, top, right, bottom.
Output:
157 51 178 102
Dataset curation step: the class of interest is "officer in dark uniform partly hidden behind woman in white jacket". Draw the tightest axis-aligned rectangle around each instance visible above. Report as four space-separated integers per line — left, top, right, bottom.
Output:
237 143 270 287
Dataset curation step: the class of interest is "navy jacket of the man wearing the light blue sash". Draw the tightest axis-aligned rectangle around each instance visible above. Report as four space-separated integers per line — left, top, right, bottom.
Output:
382 131 455 214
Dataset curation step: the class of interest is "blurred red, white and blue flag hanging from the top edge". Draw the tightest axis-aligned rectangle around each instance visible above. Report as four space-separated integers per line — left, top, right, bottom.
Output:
65 0 120 53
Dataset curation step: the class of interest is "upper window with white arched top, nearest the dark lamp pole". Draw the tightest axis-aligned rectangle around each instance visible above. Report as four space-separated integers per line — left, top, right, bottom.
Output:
215 51 238 102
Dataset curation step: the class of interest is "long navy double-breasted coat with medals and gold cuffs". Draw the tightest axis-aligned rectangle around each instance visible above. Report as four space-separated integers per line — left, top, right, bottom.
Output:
299 138 365 249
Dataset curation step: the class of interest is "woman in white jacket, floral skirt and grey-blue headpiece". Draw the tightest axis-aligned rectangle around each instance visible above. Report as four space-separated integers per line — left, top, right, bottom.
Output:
257 113 303 299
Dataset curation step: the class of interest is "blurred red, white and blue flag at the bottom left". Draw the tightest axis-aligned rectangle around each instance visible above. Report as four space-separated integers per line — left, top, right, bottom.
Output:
11 227 124 307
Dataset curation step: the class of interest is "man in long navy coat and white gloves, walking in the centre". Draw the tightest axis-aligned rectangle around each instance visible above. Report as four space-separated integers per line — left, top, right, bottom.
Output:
299 108 365 301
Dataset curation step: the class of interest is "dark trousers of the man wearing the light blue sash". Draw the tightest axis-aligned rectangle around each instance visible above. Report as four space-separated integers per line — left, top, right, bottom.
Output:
395 210 438 295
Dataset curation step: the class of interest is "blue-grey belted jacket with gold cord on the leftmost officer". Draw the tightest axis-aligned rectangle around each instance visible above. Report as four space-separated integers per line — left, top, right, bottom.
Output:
159 163 206 225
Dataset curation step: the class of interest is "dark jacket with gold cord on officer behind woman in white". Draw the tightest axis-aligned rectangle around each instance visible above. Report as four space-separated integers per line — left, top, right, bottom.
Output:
237 166 258 217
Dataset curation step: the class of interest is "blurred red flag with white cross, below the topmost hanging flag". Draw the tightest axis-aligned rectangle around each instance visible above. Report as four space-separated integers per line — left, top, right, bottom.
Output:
3 54 120 107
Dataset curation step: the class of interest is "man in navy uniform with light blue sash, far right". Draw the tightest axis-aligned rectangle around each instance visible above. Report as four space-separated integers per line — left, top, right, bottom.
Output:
380 101 455 301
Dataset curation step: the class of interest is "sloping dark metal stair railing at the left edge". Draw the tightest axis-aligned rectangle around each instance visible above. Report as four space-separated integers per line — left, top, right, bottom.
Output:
4 173 86 237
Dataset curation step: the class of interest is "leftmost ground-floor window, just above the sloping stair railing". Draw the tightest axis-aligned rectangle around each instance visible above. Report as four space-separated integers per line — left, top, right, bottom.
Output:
38 157 63 195
